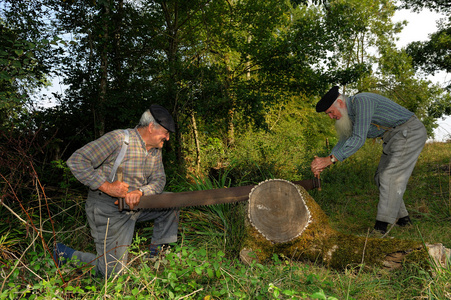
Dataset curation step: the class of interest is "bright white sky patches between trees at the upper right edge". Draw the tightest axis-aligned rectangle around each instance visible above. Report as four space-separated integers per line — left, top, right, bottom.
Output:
393 9 451 142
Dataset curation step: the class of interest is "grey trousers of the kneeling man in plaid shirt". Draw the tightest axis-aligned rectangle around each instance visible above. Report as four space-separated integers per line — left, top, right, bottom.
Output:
73 191 179 276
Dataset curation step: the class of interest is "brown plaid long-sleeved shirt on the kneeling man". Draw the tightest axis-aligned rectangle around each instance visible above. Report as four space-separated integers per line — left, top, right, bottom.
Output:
67 128 166 195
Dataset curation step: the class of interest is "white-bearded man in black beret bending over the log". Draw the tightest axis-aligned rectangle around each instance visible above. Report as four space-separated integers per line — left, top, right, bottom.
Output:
311 86 427 234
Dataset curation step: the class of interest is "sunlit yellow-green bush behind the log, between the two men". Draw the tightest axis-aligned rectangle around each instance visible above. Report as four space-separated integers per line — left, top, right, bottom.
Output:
229 97 331 183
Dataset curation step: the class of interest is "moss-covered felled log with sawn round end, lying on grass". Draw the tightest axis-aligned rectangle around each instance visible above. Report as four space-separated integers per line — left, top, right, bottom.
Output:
240 179 450 269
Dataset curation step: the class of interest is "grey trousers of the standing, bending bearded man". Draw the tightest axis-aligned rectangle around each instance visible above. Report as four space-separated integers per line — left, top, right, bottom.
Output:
375 116 427 224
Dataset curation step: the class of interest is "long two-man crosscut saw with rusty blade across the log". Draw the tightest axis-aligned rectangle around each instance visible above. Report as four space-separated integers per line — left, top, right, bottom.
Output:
118 177 321 211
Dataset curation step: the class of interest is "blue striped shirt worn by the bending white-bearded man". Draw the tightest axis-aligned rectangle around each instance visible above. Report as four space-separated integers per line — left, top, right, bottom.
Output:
331 93 414 161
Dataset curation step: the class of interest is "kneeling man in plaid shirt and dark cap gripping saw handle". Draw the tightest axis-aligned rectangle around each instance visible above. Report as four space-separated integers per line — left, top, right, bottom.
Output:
55 105 179 276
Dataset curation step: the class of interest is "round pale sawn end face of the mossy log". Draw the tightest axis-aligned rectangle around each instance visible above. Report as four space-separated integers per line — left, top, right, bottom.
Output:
248 179 310 243
